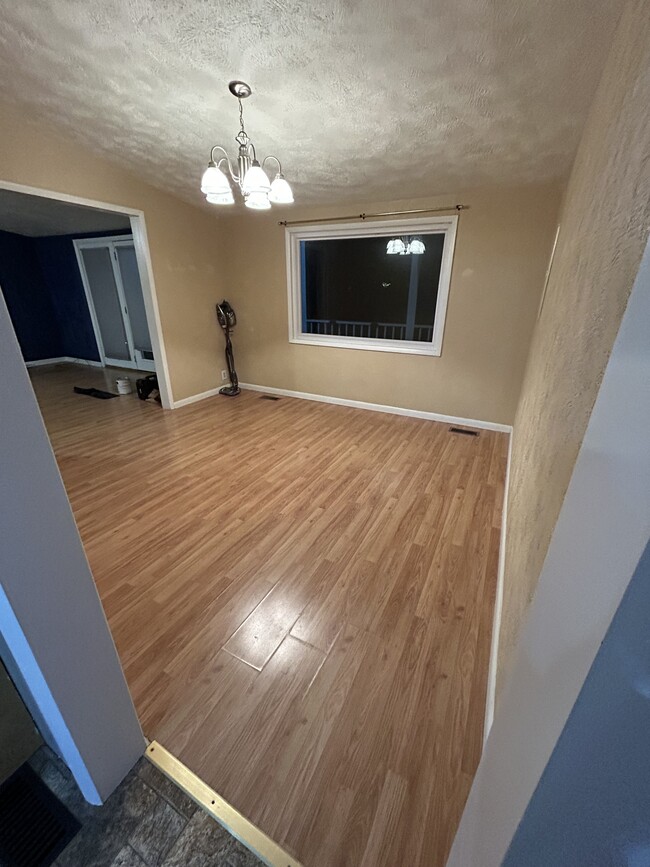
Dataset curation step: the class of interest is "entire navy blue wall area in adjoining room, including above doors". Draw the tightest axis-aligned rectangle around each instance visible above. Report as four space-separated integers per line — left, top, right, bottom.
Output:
0 230 129 361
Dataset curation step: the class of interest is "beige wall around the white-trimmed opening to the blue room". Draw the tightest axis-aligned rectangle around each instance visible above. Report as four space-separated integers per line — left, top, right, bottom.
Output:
0 105 224 400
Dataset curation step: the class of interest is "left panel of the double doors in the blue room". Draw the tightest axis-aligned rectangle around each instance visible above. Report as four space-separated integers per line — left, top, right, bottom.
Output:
80 244 133 366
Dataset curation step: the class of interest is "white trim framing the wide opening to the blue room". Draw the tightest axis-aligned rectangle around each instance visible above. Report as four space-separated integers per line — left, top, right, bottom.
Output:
0 178 174 409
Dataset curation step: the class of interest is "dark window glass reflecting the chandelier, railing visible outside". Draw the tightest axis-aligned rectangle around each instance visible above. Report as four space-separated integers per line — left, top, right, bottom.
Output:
300 232 445 342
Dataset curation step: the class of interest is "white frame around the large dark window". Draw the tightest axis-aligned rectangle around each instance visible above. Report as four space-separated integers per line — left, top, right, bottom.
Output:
285 216 458 356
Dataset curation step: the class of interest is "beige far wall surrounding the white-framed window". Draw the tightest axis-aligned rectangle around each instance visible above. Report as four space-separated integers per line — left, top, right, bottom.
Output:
223 186 560 424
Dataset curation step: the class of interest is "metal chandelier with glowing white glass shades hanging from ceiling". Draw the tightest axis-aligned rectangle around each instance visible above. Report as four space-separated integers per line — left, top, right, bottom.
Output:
201 81 293 211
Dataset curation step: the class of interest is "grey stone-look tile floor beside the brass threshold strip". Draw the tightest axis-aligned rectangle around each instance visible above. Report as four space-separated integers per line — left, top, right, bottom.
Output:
30 747 262 867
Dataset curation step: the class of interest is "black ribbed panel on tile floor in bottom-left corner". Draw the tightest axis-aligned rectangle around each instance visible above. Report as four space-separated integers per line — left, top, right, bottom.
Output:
0 764 81 867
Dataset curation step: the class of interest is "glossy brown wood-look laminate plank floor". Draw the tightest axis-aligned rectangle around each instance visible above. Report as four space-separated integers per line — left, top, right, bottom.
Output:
32 367 507 867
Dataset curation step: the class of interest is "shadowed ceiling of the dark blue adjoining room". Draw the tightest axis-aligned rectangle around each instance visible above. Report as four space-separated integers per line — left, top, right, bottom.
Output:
0 190 131 238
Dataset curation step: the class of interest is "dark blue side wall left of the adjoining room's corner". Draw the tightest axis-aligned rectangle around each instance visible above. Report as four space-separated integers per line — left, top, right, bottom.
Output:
0 231 67 361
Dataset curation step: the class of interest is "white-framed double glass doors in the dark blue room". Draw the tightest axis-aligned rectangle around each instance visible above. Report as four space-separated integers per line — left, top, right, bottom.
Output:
73 235 156 371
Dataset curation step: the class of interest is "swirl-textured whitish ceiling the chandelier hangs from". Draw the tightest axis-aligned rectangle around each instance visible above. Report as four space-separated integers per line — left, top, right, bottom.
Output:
0 0 623 210
